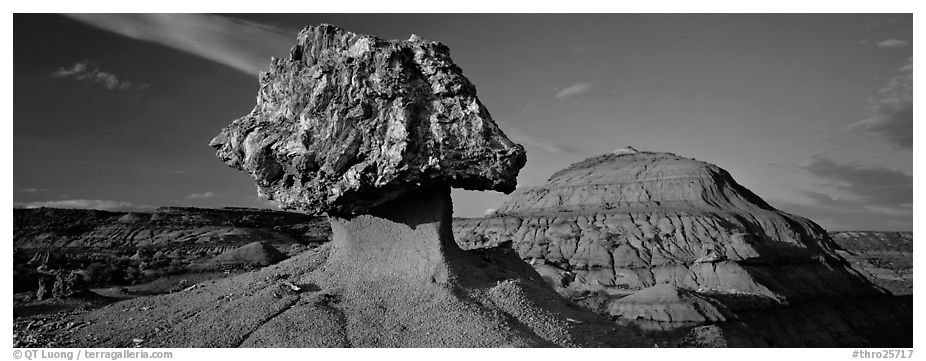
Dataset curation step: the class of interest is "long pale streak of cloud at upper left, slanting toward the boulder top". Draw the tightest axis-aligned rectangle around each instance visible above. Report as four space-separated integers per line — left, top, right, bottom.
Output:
68 14 294 76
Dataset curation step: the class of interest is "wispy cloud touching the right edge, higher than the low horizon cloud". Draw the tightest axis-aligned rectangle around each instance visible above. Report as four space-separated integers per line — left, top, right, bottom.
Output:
849 57 913 149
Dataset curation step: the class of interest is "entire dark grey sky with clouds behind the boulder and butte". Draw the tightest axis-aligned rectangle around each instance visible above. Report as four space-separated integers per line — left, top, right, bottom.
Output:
12 14 913 231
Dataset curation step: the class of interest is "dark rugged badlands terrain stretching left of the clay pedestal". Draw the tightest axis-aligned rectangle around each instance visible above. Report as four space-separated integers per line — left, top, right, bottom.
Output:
13 207 331 292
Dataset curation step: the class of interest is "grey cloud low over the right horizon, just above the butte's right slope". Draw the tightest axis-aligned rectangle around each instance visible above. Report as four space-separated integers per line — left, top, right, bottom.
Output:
798 155 913 210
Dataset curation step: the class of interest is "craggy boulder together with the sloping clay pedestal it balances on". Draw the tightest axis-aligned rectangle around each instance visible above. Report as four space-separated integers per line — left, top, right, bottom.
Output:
61 25 651 347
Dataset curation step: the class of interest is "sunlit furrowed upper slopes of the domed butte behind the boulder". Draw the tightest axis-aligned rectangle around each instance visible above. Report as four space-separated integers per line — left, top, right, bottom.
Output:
456 148 872 301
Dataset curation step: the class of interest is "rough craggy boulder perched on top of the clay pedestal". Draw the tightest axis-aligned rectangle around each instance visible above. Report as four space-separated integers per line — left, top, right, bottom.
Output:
211 25 526 215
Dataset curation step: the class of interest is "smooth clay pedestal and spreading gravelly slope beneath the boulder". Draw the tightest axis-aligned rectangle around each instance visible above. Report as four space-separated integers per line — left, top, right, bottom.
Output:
61 188 652 347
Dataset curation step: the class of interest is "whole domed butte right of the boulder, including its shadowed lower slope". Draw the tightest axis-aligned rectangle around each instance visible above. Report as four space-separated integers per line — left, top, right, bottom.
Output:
454 149 912 346
